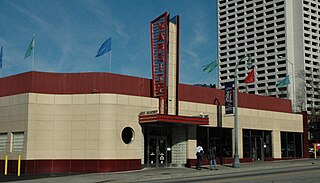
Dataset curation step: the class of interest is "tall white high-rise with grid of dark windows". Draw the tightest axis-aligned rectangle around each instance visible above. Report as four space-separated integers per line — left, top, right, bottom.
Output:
217 0 320 113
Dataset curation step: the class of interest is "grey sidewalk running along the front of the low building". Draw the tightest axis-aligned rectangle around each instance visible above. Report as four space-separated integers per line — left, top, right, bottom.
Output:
0 159 320 183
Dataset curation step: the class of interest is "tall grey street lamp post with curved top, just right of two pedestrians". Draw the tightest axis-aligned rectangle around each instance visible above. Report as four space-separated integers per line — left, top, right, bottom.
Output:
233 55 251 168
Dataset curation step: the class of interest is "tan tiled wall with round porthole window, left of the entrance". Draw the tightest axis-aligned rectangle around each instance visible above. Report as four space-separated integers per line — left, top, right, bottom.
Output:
0 93 158 159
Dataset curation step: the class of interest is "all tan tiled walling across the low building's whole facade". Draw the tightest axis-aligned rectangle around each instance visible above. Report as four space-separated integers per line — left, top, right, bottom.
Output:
0 93 303 161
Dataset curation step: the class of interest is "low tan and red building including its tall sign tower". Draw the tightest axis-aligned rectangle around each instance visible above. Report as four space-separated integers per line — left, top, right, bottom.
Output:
0 13 307 174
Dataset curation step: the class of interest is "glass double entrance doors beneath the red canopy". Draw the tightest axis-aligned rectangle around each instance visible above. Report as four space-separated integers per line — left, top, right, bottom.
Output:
148 136 168 167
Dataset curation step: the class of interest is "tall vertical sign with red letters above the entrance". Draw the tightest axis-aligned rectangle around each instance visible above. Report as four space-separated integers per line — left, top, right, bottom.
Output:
150 12 169 97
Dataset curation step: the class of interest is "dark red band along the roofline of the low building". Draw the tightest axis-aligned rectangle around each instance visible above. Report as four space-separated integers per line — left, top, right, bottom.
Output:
0 72 291 113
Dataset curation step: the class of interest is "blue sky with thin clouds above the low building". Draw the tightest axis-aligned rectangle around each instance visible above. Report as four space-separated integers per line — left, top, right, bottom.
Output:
0 0 217 84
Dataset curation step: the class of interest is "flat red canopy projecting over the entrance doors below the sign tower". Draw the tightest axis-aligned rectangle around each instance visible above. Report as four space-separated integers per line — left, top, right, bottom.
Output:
139 114 209 125
